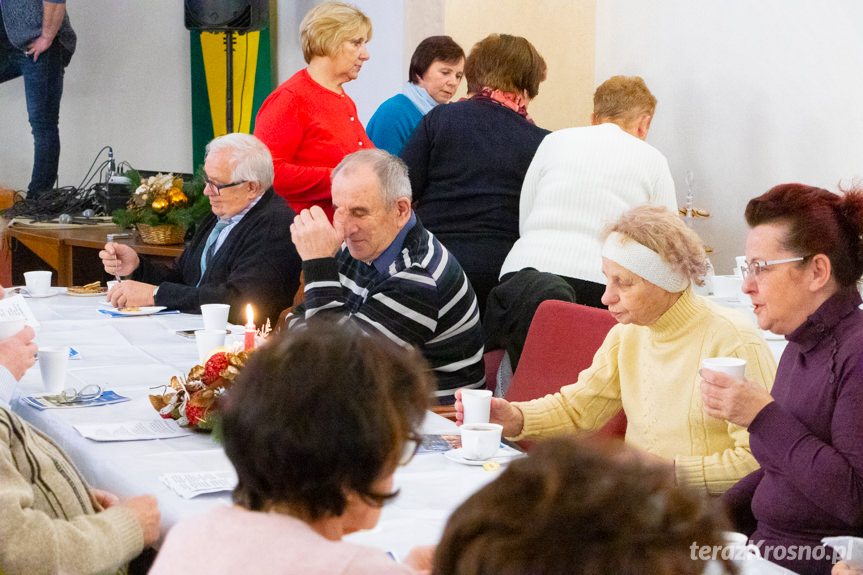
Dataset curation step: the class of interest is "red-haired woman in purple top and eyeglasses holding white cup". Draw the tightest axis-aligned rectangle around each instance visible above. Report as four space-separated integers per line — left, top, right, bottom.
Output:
701 184 863 574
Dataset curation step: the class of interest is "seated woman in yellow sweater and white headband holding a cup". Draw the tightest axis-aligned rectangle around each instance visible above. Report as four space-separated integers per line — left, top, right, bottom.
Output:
455 206 776 493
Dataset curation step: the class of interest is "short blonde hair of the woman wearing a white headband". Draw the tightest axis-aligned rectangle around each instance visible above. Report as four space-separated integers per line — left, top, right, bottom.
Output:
602 205 707 286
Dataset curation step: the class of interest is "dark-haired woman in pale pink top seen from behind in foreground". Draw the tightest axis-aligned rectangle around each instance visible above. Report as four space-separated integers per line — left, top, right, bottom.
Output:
152 322 432 574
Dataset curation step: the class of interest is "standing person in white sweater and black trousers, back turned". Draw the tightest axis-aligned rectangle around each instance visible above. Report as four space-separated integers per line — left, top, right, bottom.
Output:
484 76 677 367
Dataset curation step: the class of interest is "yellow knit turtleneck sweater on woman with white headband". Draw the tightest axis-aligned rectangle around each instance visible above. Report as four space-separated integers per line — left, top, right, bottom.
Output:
514 289 776 493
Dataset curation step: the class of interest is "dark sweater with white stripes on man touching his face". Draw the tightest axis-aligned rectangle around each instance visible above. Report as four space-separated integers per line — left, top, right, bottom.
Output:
291 221 485 396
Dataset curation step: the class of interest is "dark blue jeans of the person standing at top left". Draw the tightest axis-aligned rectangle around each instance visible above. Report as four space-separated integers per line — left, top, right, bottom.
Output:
0 10 69 197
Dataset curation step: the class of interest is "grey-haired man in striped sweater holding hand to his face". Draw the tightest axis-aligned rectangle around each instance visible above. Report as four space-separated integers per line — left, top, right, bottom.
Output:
288 150 484 404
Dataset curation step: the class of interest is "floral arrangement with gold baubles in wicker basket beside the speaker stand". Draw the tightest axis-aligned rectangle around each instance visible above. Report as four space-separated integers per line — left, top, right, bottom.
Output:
112 170 210 230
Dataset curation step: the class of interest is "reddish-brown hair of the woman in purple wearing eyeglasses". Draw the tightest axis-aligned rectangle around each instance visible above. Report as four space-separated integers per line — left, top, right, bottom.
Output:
746 184 863 287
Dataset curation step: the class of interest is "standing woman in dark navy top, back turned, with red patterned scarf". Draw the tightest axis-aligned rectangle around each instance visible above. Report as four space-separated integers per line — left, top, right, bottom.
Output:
401 34 549 313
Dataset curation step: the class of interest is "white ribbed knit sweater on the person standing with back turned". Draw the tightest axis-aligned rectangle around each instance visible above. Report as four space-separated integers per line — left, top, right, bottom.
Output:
501 123 677 283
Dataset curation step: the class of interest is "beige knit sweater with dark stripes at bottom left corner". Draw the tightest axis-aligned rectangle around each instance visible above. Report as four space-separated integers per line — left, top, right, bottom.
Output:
0 407 143 575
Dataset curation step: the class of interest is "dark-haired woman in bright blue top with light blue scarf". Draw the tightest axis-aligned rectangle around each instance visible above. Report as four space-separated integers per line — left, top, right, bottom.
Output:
366 36 464 155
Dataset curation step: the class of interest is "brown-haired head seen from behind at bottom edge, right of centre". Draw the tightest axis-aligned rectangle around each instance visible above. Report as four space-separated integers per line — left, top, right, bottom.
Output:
432 436 727 575
